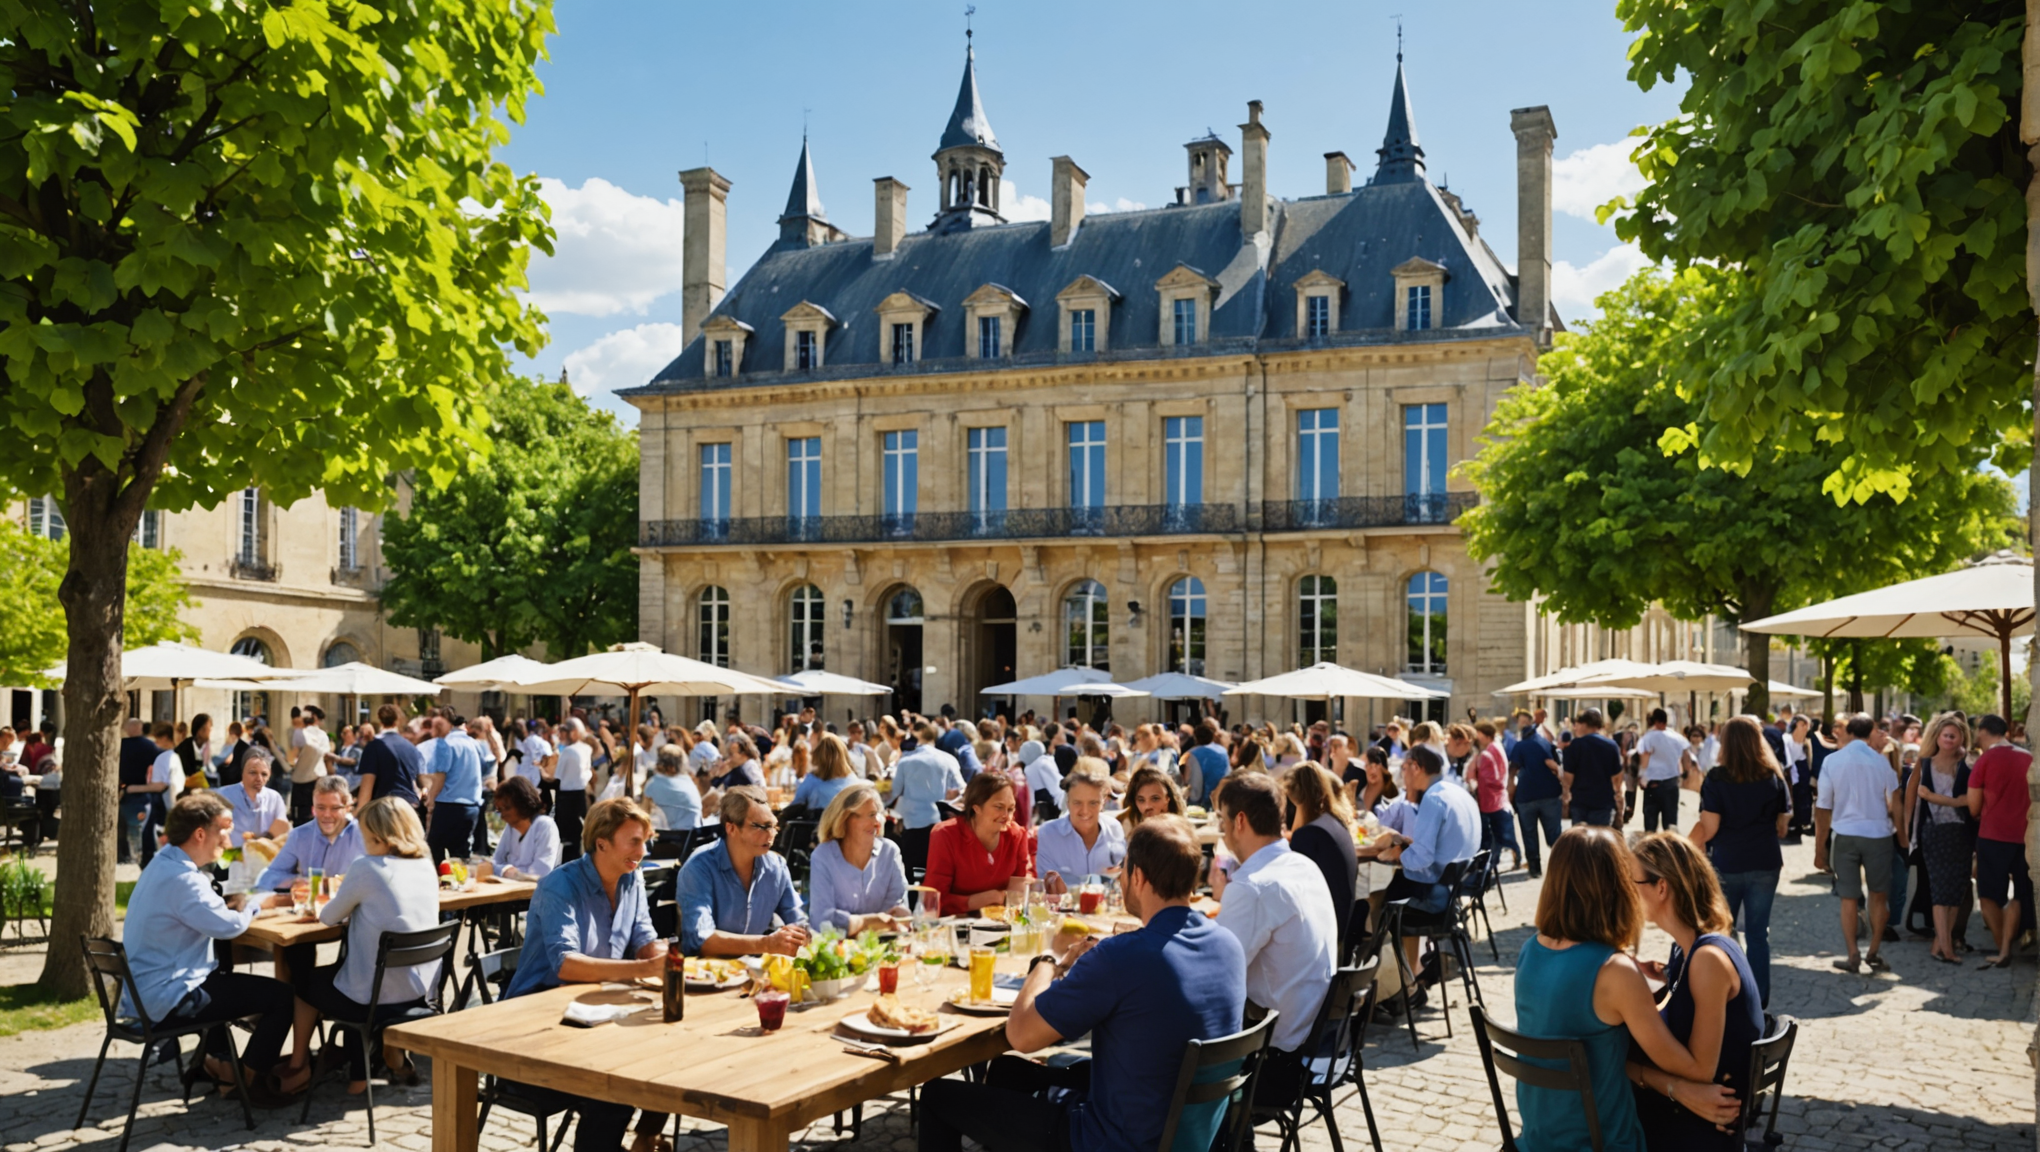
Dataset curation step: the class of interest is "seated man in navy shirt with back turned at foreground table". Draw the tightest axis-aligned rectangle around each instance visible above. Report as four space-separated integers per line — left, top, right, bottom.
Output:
920 816 1246 1152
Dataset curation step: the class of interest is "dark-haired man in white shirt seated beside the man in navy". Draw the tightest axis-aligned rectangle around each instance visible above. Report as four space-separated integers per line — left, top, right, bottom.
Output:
1212 773 1338 1101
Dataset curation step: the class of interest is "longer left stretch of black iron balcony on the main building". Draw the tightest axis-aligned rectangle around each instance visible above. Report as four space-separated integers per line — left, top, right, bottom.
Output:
639 504 1244 548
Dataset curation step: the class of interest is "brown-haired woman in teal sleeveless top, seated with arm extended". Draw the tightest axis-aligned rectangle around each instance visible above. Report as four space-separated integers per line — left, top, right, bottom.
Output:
1516 824 1736 1152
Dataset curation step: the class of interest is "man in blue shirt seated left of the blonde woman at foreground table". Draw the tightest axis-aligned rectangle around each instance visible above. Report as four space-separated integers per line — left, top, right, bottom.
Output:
677 785 808 956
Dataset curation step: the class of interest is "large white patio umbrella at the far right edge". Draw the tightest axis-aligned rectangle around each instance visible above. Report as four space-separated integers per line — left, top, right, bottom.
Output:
1742 553 2034 720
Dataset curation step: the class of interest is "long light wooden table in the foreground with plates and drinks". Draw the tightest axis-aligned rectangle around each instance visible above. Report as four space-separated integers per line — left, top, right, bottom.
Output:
388 958 1020 1152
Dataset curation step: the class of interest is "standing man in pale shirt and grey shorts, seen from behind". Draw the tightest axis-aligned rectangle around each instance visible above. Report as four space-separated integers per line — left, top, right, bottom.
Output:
1814 712 1905 973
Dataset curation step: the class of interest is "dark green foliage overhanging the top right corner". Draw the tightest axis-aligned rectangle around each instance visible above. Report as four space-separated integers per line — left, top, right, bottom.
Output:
1603 0 2034 502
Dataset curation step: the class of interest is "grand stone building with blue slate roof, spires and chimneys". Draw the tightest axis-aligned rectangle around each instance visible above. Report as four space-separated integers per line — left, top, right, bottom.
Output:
622 55 1623 724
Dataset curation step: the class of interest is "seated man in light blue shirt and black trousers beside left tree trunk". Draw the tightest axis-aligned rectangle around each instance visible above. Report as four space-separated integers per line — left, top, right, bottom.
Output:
120 791 312 1107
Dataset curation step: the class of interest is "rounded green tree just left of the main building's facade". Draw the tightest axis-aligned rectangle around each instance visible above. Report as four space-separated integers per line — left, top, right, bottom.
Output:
384 379 639 659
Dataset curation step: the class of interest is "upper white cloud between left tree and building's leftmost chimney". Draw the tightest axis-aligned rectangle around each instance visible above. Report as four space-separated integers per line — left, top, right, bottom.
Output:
530 175 681 316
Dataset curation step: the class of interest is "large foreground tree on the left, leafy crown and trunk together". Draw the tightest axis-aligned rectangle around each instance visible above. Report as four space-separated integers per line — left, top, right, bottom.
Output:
0 0 553 997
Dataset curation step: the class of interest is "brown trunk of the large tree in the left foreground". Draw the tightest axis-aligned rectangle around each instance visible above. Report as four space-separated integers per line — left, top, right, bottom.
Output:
41 470 137 999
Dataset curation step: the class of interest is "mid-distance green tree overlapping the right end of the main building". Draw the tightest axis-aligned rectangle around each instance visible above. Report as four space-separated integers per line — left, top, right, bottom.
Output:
1461 267 2011 712
